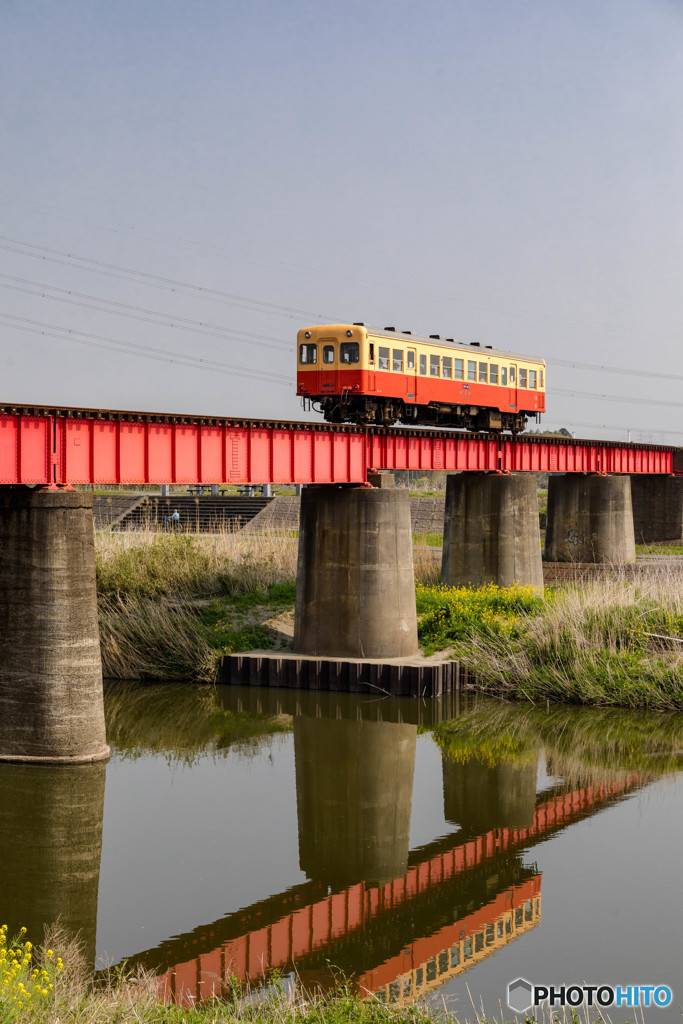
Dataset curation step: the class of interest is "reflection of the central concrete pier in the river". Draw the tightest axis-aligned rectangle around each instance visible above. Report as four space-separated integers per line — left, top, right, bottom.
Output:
294 717 418 887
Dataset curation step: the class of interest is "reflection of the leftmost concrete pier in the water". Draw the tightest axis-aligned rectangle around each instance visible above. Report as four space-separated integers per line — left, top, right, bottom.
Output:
0 764 105 966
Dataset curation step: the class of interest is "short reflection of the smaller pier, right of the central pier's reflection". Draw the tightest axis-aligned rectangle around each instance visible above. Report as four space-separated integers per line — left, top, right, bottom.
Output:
443 757 537 836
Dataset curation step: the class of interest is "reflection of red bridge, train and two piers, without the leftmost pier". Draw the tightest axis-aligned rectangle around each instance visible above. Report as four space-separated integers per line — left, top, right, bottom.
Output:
135 695 641 1002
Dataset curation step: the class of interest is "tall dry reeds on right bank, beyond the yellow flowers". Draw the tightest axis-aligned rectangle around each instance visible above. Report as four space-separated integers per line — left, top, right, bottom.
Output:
459 566 683 711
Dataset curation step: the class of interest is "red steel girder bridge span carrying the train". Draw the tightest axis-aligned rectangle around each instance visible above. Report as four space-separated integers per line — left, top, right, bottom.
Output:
0 404 683 485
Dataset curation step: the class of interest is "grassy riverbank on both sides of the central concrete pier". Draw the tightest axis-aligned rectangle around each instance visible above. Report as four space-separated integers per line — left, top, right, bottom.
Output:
96 532 683 711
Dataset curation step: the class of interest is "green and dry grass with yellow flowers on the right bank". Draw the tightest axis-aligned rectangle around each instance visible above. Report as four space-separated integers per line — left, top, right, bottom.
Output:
418 572 683 711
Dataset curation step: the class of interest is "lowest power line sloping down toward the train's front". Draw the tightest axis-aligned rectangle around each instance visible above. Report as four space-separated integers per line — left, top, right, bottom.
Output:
0 312 292 387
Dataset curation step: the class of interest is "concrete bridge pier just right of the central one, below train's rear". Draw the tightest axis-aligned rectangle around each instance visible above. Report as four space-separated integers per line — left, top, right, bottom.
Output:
441 473 543 591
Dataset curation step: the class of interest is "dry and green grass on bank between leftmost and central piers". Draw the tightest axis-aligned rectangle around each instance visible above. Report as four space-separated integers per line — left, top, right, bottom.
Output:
95 530 440 682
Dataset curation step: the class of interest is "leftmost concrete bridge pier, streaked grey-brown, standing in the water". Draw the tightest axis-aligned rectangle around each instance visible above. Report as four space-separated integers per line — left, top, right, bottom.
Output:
0 486 110 764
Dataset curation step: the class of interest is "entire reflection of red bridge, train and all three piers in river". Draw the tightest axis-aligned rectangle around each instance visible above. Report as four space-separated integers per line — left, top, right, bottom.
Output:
0 691 645 1001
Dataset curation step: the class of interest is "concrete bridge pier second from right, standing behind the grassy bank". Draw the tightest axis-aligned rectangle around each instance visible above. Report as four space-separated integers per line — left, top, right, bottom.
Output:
546 473 636 564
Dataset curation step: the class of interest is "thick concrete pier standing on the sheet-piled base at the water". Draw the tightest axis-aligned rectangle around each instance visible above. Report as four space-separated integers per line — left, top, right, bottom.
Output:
294 485 418 658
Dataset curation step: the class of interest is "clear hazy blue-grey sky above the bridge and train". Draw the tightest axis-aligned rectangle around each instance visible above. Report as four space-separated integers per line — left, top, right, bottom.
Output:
0 0 683 444
